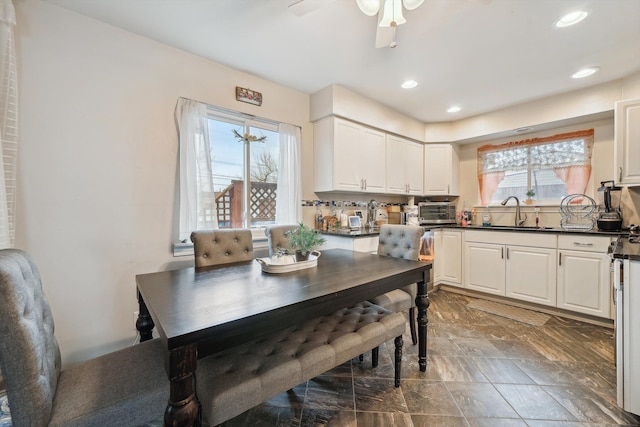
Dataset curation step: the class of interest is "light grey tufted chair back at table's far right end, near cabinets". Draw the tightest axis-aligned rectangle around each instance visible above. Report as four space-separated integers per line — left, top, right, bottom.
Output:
378 224 424 261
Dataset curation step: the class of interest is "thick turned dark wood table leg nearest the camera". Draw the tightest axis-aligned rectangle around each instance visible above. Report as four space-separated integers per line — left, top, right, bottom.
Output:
164 344 202 427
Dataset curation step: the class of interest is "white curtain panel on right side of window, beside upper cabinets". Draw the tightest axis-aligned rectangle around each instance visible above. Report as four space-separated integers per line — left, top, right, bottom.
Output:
276 123 302 224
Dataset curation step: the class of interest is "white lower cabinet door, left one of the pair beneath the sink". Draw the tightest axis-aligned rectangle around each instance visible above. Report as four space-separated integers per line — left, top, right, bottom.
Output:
464 242 505 296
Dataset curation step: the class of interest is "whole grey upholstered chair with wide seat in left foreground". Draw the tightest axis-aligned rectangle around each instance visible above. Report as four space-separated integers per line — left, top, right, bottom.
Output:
0 249 169 427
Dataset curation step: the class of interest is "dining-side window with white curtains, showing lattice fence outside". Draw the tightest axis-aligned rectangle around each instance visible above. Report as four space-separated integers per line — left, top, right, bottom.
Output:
175 98 301 242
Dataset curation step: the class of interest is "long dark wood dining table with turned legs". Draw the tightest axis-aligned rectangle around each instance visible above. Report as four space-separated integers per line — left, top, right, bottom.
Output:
136 249 431 426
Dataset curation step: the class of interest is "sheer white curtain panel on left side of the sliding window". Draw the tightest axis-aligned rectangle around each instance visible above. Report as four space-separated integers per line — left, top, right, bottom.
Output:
175 98 218 241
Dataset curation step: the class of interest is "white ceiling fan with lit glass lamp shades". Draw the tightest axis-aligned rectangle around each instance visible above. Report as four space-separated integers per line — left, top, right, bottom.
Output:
289 0 491 48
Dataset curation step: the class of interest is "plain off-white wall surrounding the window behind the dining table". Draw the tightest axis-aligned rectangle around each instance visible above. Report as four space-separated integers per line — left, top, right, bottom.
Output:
15 0 313 364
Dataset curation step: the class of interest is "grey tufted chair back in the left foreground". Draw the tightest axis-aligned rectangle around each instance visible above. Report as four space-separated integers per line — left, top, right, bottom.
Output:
0 249 61 426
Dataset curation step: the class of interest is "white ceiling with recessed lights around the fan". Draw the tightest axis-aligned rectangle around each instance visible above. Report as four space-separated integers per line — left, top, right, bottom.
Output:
46 0 640 123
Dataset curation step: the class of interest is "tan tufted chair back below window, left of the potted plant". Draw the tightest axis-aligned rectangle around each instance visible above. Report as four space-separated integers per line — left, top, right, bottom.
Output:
191 228 253 267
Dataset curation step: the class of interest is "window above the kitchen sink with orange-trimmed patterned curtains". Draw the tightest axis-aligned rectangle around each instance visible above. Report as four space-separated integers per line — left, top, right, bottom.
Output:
478 129 593 205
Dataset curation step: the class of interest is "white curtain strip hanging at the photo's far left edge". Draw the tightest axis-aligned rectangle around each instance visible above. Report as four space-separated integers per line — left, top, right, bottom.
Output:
0 0 18 249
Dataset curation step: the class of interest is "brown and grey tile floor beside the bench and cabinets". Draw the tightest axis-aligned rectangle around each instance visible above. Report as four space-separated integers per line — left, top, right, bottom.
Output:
219 291 640 427
